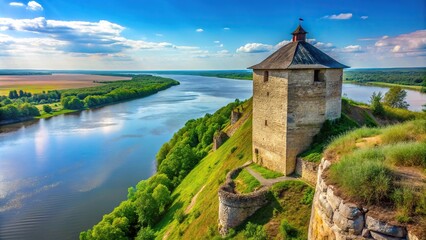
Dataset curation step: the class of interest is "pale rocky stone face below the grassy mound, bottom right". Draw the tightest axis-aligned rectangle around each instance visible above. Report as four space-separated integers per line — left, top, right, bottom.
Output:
309 159 418 240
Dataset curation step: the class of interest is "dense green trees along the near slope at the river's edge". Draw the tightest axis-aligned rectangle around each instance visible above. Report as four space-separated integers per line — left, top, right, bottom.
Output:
80 100 242 239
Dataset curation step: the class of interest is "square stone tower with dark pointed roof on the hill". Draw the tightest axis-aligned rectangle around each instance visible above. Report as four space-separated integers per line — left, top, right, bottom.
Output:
250 25 347 175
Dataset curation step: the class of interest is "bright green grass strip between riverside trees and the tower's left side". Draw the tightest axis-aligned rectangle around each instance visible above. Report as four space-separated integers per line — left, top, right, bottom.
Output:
154 106 252 239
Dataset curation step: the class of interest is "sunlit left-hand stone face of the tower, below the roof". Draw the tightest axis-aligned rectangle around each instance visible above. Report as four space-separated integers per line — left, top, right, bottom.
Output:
253 70 289 173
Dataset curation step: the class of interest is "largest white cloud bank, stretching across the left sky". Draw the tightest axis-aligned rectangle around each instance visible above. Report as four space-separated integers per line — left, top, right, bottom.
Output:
0 17 197 54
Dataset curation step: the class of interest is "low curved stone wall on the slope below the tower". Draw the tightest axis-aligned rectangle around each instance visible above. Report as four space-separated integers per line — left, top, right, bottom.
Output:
219 167 268 235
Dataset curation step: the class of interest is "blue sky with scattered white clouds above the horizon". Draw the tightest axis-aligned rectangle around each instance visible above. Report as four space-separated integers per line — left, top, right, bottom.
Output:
0 0 426 70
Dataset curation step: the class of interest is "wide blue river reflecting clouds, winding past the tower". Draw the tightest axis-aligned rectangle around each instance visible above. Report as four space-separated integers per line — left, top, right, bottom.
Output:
0 75 426 239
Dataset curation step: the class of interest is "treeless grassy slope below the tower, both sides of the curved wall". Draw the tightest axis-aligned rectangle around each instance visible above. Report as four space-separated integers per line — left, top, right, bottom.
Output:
154 102 313 239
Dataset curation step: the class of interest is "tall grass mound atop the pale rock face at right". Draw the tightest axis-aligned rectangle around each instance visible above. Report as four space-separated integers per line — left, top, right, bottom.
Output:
326 119 426 223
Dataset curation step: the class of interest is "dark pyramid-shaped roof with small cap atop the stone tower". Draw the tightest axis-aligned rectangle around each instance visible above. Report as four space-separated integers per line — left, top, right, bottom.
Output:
249 40 348 70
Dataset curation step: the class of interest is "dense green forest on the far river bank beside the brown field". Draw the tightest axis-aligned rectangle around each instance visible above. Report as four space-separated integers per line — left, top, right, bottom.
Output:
0 75 179 122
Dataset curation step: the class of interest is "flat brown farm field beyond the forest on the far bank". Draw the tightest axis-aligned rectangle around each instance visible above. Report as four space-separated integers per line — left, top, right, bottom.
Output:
0 74 131 96
